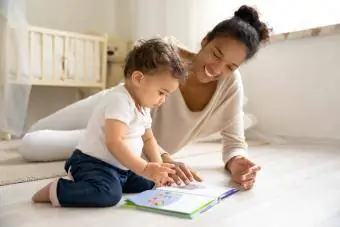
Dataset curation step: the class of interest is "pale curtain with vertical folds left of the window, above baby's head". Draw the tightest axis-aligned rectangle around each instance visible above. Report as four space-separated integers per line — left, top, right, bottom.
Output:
130 0 200 49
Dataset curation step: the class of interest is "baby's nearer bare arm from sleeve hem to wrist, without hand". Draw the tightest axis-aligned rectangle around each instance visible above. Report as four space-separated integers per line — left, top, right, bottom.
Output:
105 119 147 175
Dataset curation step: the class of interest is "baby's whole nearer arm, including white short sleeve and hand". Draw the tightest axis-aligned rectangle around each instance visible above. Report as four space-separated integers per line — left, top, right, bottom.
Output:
104 94 174 184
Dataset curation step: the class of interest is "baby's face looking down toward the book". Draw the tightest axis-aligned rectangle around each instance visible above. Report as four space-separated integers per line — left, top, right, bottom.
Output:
135 72 179 108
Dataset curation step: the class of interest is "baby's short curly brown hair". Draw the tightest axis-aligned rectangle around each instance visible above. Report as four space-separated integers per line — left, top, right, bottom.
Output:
124 38 187 79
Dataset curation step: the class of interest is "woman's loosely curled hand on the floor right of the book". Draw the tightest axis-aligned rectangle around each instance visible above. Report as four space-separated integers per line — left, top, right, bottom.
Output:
225 156 261 190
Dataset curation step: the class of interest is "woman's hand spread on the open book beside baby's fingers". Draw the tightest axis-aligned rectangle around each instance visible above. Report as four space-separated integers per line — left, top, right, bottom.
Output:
162 154 203 185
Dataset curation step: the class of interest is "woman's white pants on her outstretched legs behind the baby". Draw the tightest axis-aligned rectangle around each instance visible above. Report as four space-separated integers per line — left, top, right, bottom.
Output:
18 90 108 161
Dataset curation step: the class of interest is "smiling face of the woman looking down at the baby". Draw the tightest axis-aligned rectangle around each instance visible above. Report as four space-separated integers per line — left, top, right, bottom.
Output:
193 37 247 83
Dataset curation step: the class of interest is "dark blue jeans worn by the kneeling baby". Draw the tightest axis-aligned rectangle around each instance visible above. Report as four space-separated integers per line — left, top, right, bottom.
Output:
57 150 155 207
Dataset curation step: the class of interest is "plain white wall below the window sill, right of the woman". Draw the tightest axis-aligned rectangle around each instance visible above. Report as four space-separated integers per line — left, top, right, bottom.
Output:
241 35 340 139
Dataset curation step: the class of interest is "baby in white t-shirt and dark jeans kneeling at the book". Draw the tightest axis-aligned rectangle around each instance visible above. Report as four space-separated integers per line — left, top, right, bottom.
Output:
32 38 186 207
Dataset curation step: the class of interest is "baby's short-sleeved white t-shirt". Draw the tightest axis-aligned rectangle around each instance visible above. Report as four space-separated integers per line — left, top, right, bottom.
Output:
77 84 152 170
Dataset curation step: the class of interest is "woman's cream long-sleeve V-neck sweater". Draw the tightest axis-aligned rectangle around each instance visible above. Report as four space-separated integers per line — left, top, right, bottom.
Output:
152 71 247 162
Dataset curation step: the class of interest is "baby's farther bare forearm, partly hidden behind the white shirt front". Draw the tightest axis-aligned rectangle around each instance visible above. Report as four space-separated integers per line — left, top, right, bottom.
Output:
143 128 163 163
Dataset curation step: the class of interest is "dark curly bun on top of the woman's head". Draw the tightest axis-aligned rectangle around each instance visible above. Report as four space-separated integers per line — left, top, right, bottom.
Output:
234 5 270 41
